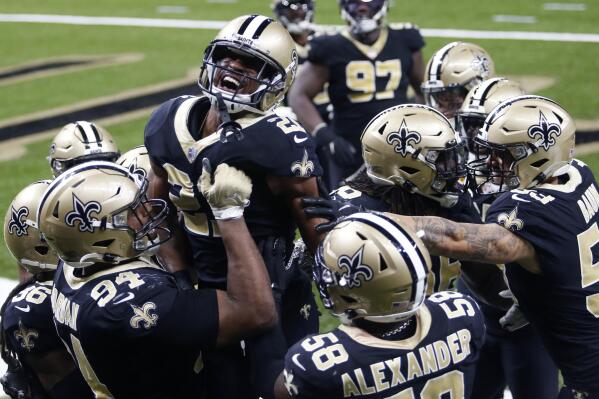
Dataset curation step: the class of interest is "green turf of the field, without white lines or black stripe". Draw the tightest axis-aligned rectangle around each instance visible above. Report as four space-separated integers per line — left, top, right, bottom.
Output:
0 0 599 340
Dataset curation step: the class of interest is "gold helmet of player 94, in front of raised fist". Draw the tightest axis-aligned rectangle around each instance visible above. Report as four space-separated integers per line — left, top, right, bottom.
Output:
37 161 170 267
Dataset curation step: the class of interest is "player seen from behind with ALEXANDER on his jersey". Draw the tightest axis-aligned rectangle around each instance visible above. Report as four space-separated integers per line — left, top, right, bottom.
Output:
275 213 485 399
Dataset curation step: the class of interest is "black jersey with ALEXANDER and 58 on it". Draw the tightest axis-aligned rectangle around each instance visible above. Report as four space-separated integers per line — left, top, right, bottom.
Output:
284 291 485 399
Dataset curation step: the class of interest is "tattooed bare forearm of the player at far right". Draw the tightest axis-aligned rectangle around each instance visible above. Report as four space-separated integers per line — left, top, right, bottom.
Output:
388 214 541 273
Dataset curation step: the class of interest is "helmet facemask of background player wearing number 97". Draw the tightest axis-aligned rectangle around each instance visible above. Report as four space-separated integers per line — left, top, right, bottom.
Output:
341 0 388 36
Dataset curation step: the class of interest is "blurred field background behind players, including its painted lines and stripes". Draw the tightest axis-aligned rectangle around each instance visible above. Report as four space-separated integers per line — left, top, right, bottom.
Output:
0 0 599 388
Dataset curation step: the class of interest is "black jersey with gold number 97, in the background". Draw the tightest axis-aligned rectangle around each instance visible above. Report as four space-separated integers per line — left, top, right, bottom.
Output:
308 24 424 148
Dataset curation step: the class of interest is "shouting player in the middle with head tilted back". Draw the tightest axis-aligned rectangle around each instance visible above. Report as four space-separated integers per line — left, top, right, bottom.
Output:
145 15 321 397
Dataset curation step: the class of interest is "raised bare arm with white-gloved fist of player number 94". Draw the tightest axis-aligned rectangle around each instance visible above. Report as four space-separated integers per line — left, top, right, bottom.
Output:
200 160 277 345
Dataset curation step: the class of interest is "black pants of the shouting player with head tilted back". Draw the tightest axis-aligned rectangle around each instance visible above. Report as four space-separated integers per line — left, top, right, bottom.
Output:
205 237 318 399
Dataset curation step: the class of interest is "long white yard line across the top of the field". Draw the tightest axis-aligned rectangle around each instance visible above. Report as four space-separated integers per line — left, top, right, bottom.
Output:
0 14 599 43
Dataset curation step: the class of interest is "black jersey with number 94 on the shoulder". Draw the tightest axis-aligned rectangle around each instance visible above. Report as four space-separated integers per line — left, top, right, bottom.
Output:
52 260 218 399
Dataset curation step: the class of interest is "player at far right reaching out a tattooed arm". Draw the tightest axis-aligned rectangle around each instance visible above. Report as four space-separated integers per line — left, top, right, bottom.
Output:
400 96 599 399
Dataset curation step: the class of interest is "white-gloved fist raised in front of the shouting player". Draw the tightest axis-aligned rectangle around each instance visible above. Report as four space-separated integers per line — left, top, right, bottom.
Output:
200 158 252 220
